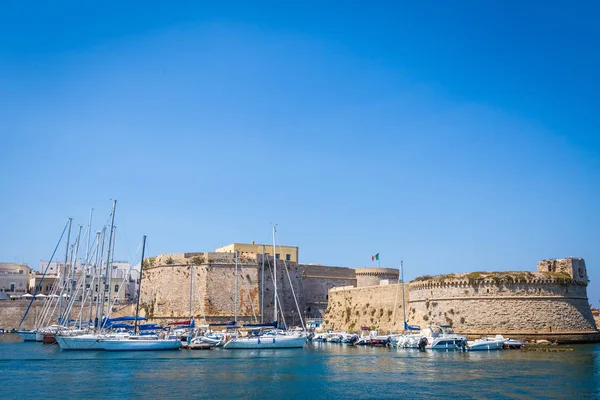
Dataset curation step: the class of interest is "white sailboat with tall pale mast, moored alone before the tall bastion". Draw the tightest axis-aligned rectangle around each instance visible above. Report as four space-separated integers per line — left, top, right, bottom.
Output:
223 225 306 349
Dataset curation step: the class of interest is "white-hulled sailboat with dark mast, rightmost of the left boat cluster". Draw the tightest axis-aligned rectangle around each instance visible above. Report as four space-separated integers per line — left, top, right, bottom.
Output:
103 235 181 351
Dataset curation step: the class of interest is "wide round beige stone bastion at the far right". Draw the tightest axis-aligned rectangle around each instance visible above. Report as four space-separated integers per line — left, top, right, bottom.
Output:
407 259 598 341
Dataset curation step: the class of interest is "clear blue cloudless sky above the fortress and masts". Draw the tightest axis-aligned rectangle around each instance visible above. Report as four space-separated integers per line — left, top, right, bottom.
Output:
0 1 600 306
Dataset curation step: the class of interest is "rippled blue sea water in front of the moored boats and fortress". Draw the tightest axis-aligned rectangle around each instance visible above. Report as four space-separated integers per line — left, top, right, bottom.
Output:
0 335 600 400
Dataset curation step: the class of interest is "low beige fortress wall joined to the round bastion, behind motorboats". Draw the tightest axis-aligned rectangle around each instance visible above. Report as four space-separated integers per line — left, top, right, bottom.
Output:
325 258 598 341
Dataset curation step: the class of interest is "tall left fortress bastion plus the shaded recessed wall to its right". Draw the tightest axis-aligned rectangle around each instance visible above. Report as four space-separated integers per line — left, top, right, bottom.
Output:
140 252 364 325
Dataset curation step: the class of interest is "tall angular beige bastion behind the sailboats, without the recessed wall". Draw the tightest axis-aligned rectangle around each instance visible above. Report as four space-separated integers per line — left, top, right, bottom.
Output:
140 252 306 323
